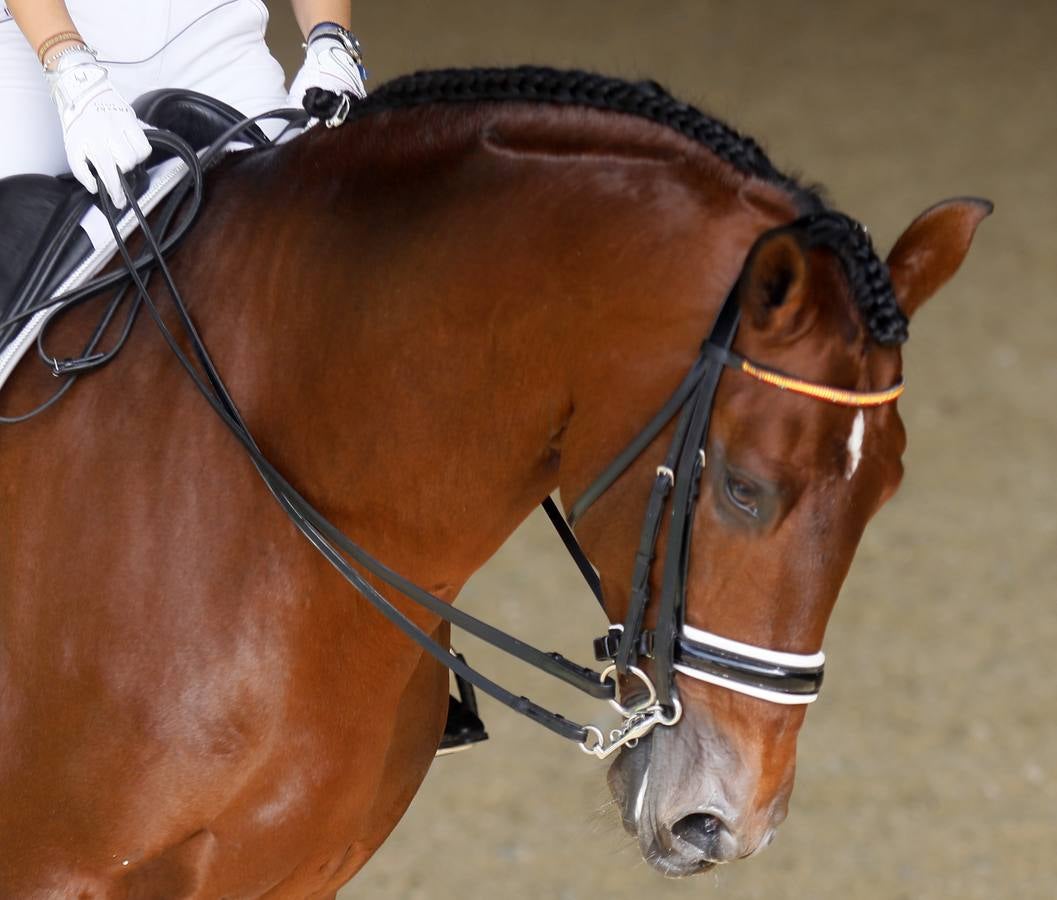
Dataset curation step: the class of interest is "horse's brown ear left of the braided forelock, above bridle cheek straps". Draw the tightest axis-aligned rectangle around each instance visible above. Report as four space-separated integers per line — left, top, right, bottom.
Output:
738 228 814 341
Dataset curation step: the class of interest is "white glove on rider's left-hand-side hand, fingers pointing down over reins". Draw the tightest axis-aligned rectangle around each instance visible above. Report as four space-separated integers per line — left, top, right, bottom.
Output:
45 50 150 208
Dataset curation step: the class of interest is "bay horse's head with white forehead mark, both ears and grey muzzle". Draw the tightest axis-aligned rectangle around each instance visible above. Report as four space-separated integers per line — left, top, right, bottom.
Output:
562 199 990 875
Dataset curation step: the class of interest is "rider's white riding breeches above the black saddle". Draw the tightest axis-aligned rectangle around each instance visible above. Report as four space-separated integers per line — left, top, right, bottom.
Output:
0 0 286 178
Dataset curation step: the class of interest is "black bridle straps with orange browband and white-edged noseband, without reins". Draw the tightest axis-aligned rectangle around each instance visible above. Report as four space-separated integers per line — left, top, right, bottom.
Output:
566 210 903 727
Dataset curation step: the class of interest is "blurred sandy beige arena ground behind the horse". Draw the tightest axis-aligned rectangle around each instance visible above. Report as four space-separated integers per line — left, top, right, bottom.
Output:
272 0 1057 900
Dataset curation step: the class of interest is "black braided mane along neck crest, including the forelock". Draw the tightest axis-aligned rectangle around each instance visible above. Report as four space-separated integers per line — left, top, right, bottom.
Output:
336 66 907 345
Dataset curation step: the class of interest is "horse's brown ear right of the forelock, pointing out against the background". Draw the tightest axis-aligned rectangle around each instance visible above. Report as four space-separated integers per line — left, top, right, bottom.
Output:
888 197 995 318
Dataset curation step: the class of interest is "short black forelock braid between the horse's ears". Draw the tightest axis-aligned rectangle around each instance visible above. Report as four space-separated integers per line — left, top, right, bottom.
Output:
794 210 909 346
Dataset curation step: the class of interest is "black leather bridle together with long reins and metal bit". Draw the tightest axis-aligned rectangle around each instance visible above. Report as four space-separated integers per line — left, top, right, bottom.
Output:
0 96 904 758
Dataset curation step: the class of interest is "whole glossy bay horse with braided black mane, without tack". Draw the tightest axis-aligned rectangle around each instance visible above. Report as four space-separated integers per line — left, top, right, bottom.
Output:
0 70 990 900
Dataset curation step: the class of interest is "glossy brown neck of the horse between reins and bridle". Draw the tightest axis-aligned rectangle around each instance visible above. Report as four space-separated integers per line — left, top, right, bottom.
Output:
190 107 792 590
